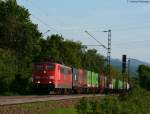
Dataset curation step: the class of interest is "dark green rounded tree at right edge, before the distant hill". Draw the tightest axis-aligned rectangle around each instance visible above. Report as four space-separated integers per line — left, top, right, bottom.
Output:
138 65 150 90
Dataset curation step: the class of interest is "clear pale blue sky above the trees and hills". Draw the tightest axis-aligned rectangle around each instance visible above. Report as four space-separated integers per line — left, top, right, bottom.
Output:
18 0 150 62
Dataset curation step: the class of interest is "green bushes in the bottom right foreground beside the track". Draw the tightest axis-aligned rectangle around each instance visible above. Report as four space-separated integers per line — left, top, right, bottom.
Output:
76 86 150 114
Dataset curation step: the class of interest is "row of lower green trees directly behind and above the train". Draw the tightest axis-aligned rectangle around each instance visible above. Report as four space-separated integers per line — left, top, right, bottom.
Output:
38 34 105 72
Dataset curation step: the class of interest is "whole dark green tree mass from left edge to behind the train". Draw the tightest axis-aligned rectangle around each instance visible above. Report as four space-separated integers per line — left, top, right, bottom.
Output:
0 0 113 95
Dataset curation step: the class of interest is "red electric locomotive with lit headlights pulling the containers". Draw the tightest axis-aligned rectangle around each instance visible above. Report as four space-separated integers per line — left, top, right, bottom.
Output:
33 62 72 93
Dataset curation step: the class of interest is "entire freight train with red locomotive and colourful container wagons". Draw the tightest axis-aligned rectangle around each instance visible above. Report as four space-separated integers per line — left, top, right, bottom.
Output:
33 61 130 94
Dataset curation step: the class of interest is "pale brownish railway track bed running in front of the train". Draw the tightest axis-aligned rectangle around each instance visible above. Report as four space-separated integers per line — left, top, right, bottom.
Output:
0 94 104 106
